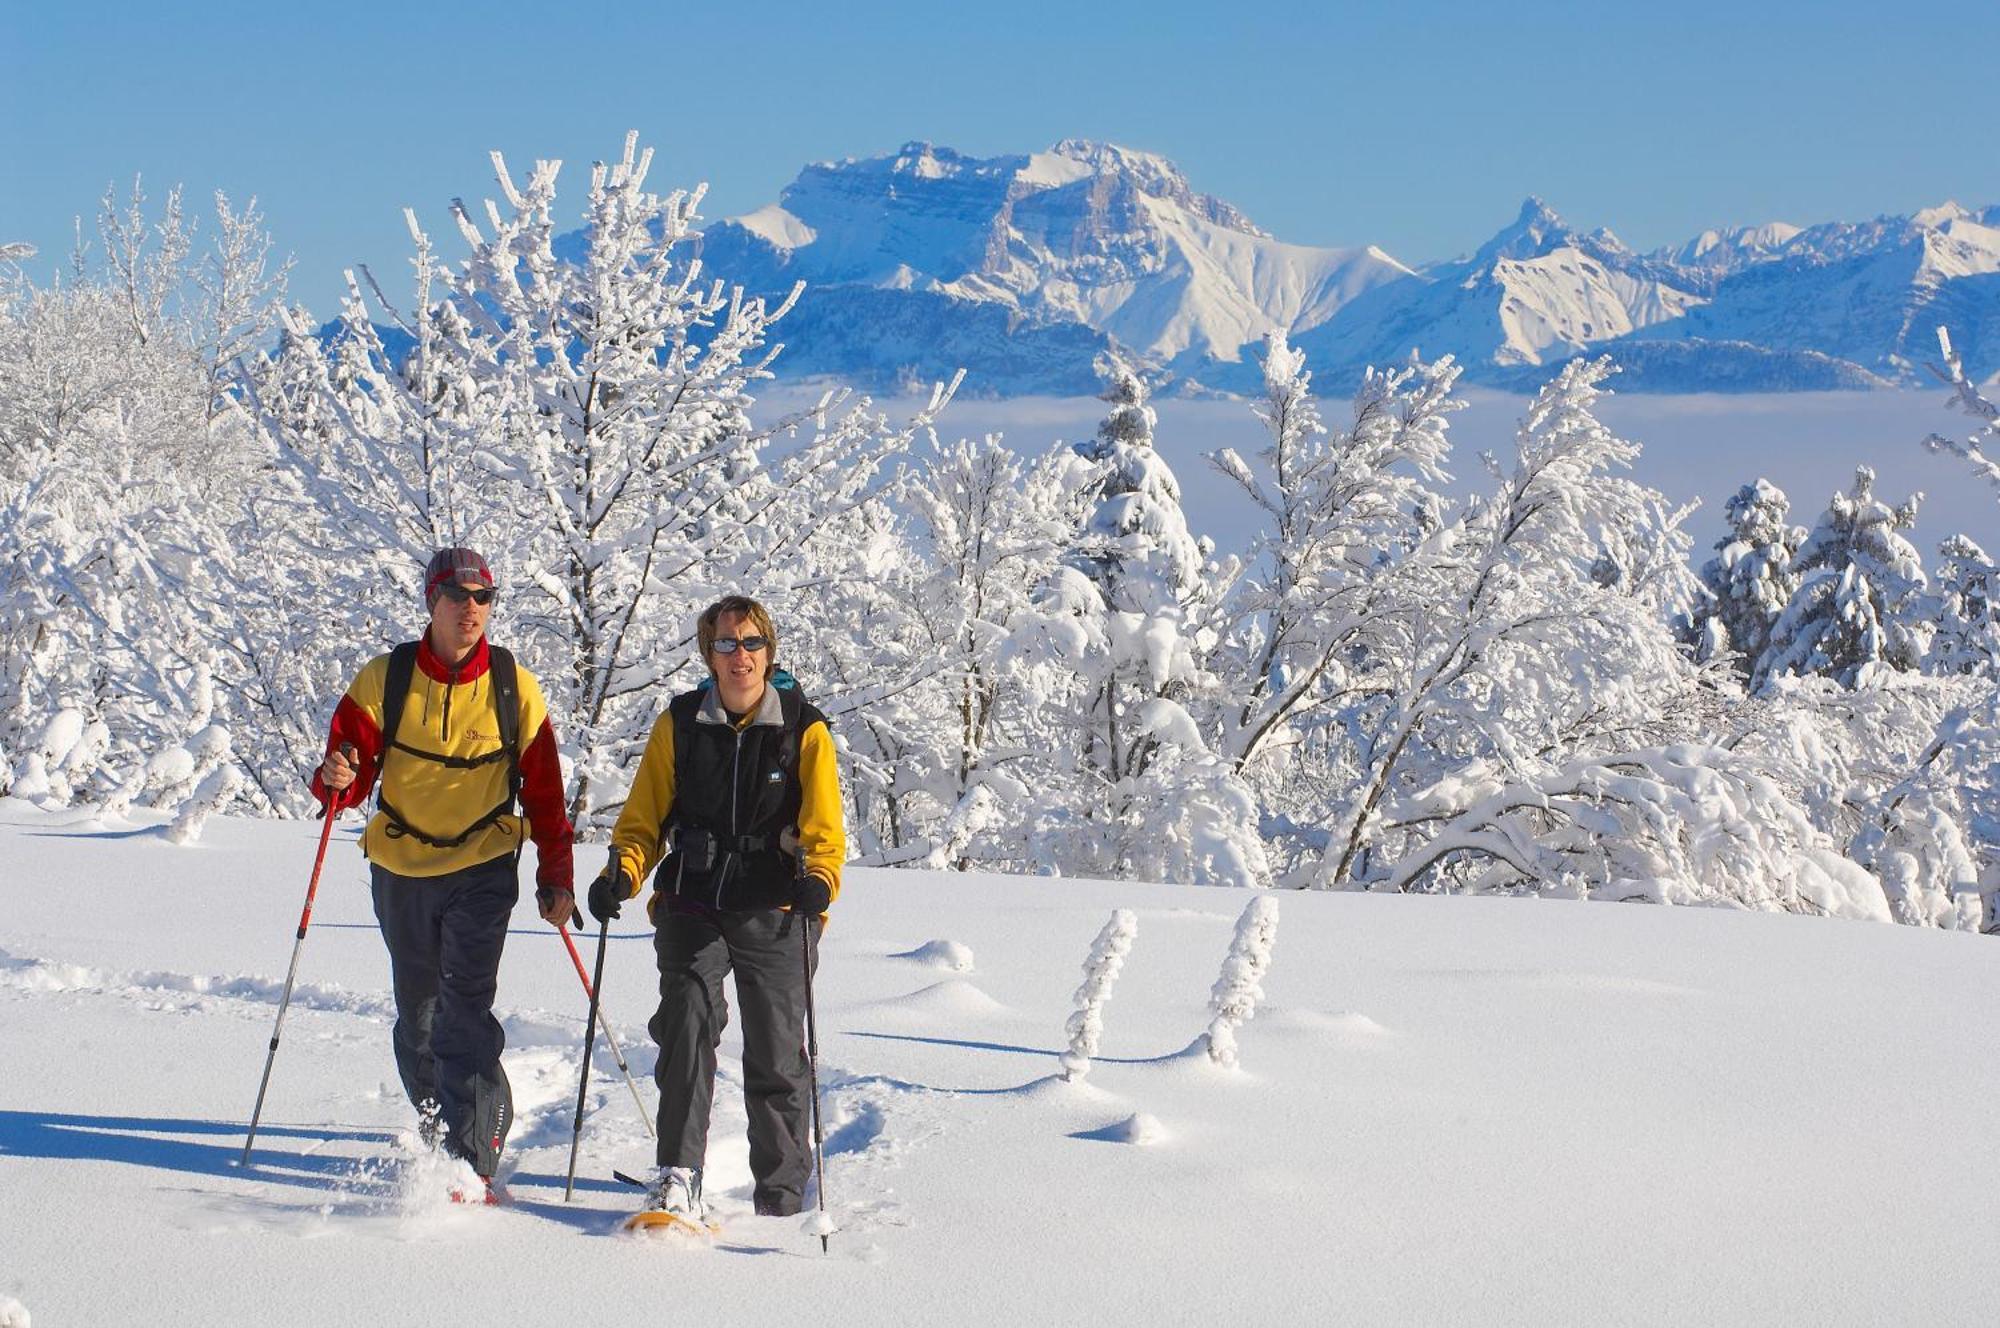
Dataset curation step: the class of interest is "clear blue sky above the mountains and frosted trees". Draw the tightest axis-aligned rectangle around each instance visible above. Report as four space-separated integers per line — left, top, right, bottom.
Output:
0 0 2000 312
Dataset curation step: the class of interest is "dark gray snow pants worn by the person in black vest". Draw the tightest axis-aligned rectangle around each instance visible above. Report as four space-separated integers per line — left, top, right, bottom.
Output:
650 900 820 1216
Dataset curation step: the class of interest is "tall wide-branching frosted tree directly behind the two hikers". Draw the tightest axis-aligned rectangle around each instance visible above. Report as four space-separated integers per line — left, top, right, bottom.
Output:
252 134 948 818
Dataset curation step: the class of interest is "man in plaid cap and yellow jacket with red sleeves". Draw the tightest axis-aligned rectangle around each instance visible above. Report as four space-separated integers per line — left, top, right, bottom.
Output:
312 548 576 1200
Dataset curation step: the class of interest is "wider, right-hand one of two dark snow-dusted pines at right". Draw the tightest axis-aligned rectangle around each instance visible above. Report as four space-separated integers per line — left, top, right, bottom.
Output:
1752 466 1932 688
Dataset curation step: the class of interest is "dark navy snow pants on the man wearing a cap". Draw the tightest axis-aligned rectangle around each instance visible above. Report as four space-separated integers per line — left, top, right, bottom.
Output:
370 854 520 1176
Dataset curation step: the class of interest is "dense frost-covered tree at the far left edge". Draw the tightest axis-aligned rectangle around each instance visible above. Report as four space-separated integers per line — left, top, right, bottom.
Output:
0 190 282 802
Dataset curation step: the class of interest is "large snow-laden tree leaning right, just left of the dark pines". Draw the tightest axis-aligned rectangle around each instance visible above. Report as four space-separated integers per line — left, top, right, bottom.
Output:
1308 360 1696 888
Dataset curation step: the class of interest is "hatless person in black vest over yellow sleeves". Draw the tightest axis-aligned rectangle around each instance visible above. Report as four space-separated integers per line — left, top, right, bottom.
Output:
590 596 848 1220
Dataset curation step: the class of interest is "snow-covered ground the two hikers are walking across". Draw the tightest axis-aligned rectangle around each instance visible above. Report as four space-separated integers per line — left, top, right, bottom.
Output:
0 802 2000 1328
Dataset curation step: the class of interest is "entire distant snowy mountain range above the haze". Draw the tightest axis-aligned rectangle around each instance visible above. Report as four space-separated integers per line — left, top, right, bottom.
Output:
612 140 2000 396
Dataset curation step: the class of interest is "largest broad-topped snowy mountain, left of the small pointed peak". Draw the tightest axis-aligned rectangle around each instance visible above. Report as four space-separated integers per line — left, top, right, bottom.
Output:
702 138 1410 390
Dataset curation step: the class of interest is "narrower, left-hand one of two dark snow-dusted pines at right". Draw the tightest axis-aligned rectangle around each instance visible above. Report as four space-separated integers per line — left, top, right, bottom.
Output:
1694 480 1806 680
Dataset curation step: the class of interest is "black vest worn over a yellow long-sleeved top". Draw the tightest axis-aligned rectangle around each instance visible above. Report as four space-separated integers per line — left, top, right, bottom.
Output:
654 684 826 910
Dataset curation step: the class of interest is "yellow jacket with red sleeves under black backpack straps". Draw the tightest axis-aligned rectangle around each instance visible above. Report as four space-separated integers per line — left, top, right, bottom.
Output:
312 636 574 890
